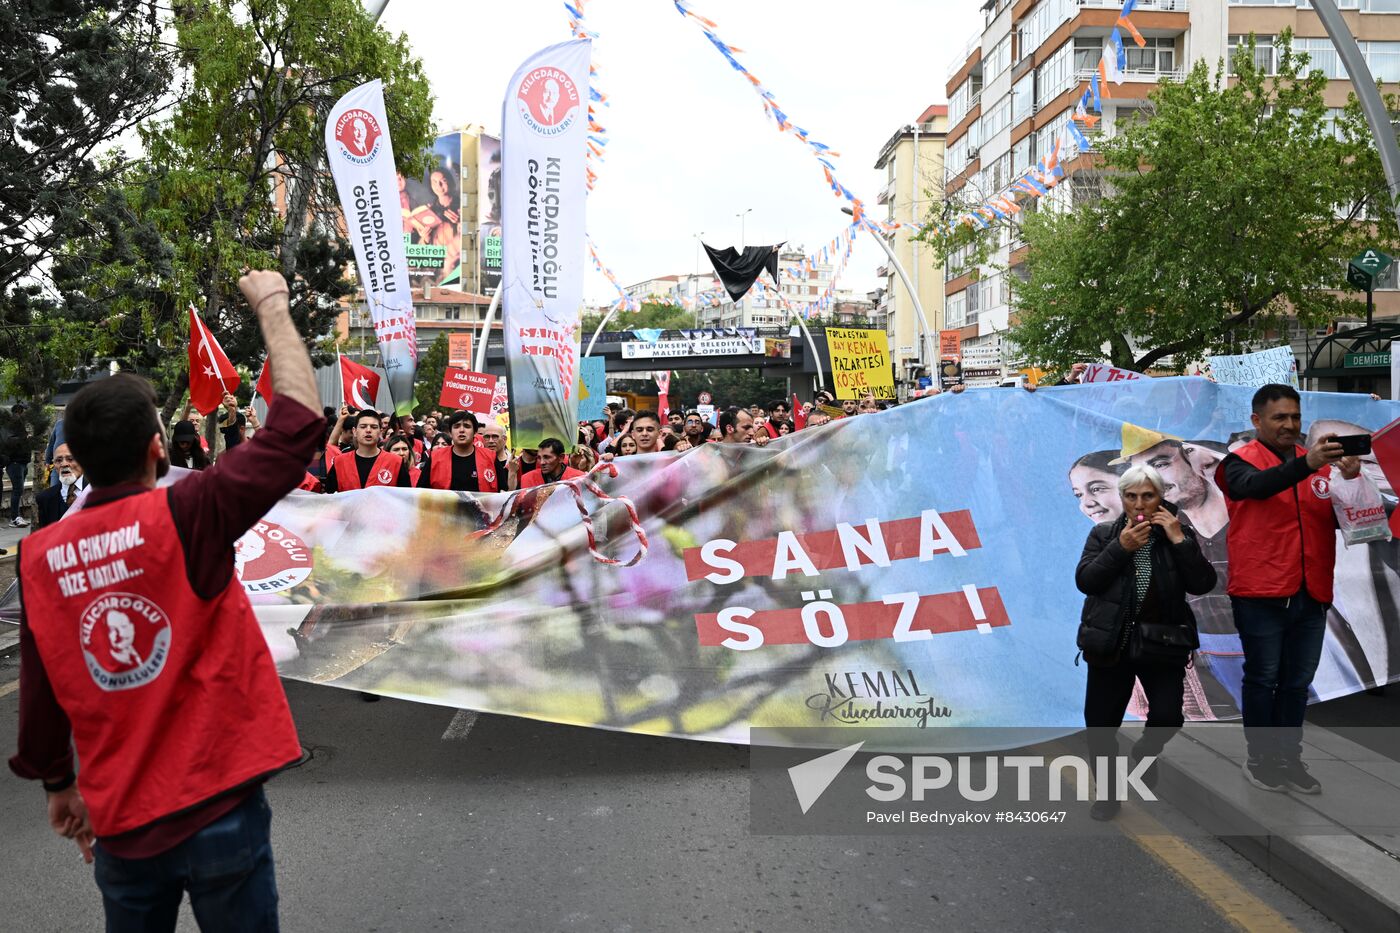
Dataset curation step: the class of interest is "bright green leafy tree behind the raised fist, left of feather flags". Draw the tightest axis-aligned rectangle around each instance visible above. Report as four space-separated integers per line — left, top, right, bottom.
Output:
56 0 433 409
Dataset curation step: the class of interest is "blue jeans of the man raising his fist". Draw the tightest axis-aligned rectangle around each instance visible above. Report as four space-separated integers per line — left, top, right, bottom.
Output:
95 787 277 933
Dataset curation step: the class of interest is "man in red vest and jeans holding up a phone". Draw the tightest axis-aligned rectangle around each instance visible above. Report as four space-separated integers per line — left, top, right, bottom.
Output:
1215 384 1361 794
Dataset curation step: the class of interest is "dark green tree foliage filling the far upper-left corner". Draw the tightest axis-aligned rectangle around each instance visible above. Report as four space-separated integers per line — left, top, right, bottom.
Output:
0 0 172 400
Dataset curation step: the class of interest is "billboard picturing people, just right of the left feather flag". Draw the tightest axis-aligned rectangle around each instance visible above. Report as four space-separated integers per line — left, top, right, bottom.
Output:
399 133 469 287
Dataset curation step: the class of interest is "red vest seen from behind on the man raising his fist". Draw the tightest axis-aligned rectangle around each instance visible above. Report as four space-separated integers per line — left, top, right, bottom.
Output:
20 489 301 836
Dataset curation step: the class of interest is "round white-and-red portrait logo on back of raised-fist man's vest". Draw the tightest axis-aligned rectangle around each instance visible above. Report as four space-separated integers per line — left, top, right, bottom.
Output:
78 593 171 692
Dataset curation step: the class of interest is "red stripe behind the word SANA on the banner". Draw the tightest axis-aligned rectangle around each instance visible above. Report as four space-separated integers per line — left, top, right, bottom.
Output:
682 509 981 581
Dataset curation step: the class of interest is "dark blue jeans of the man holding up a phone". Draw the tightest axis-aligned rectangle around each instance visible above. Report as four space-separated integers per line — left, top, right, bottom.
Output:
1231 591 1327 758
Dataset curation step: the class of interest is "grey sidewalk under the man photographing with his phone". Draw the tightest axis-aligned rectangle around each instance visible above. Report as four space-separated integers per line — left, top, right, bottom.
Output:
1124 723 1400 932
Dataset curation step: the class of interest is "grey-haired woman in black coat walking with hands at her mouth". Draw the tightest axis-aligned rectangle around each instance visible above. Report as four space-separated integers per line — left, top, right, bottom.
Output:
1074 465 1215 820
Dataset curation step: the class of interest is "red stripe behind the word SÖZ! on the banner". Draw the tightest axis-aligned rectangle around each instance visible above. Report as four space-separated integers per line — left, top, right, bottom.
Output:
696 587 1011 650
